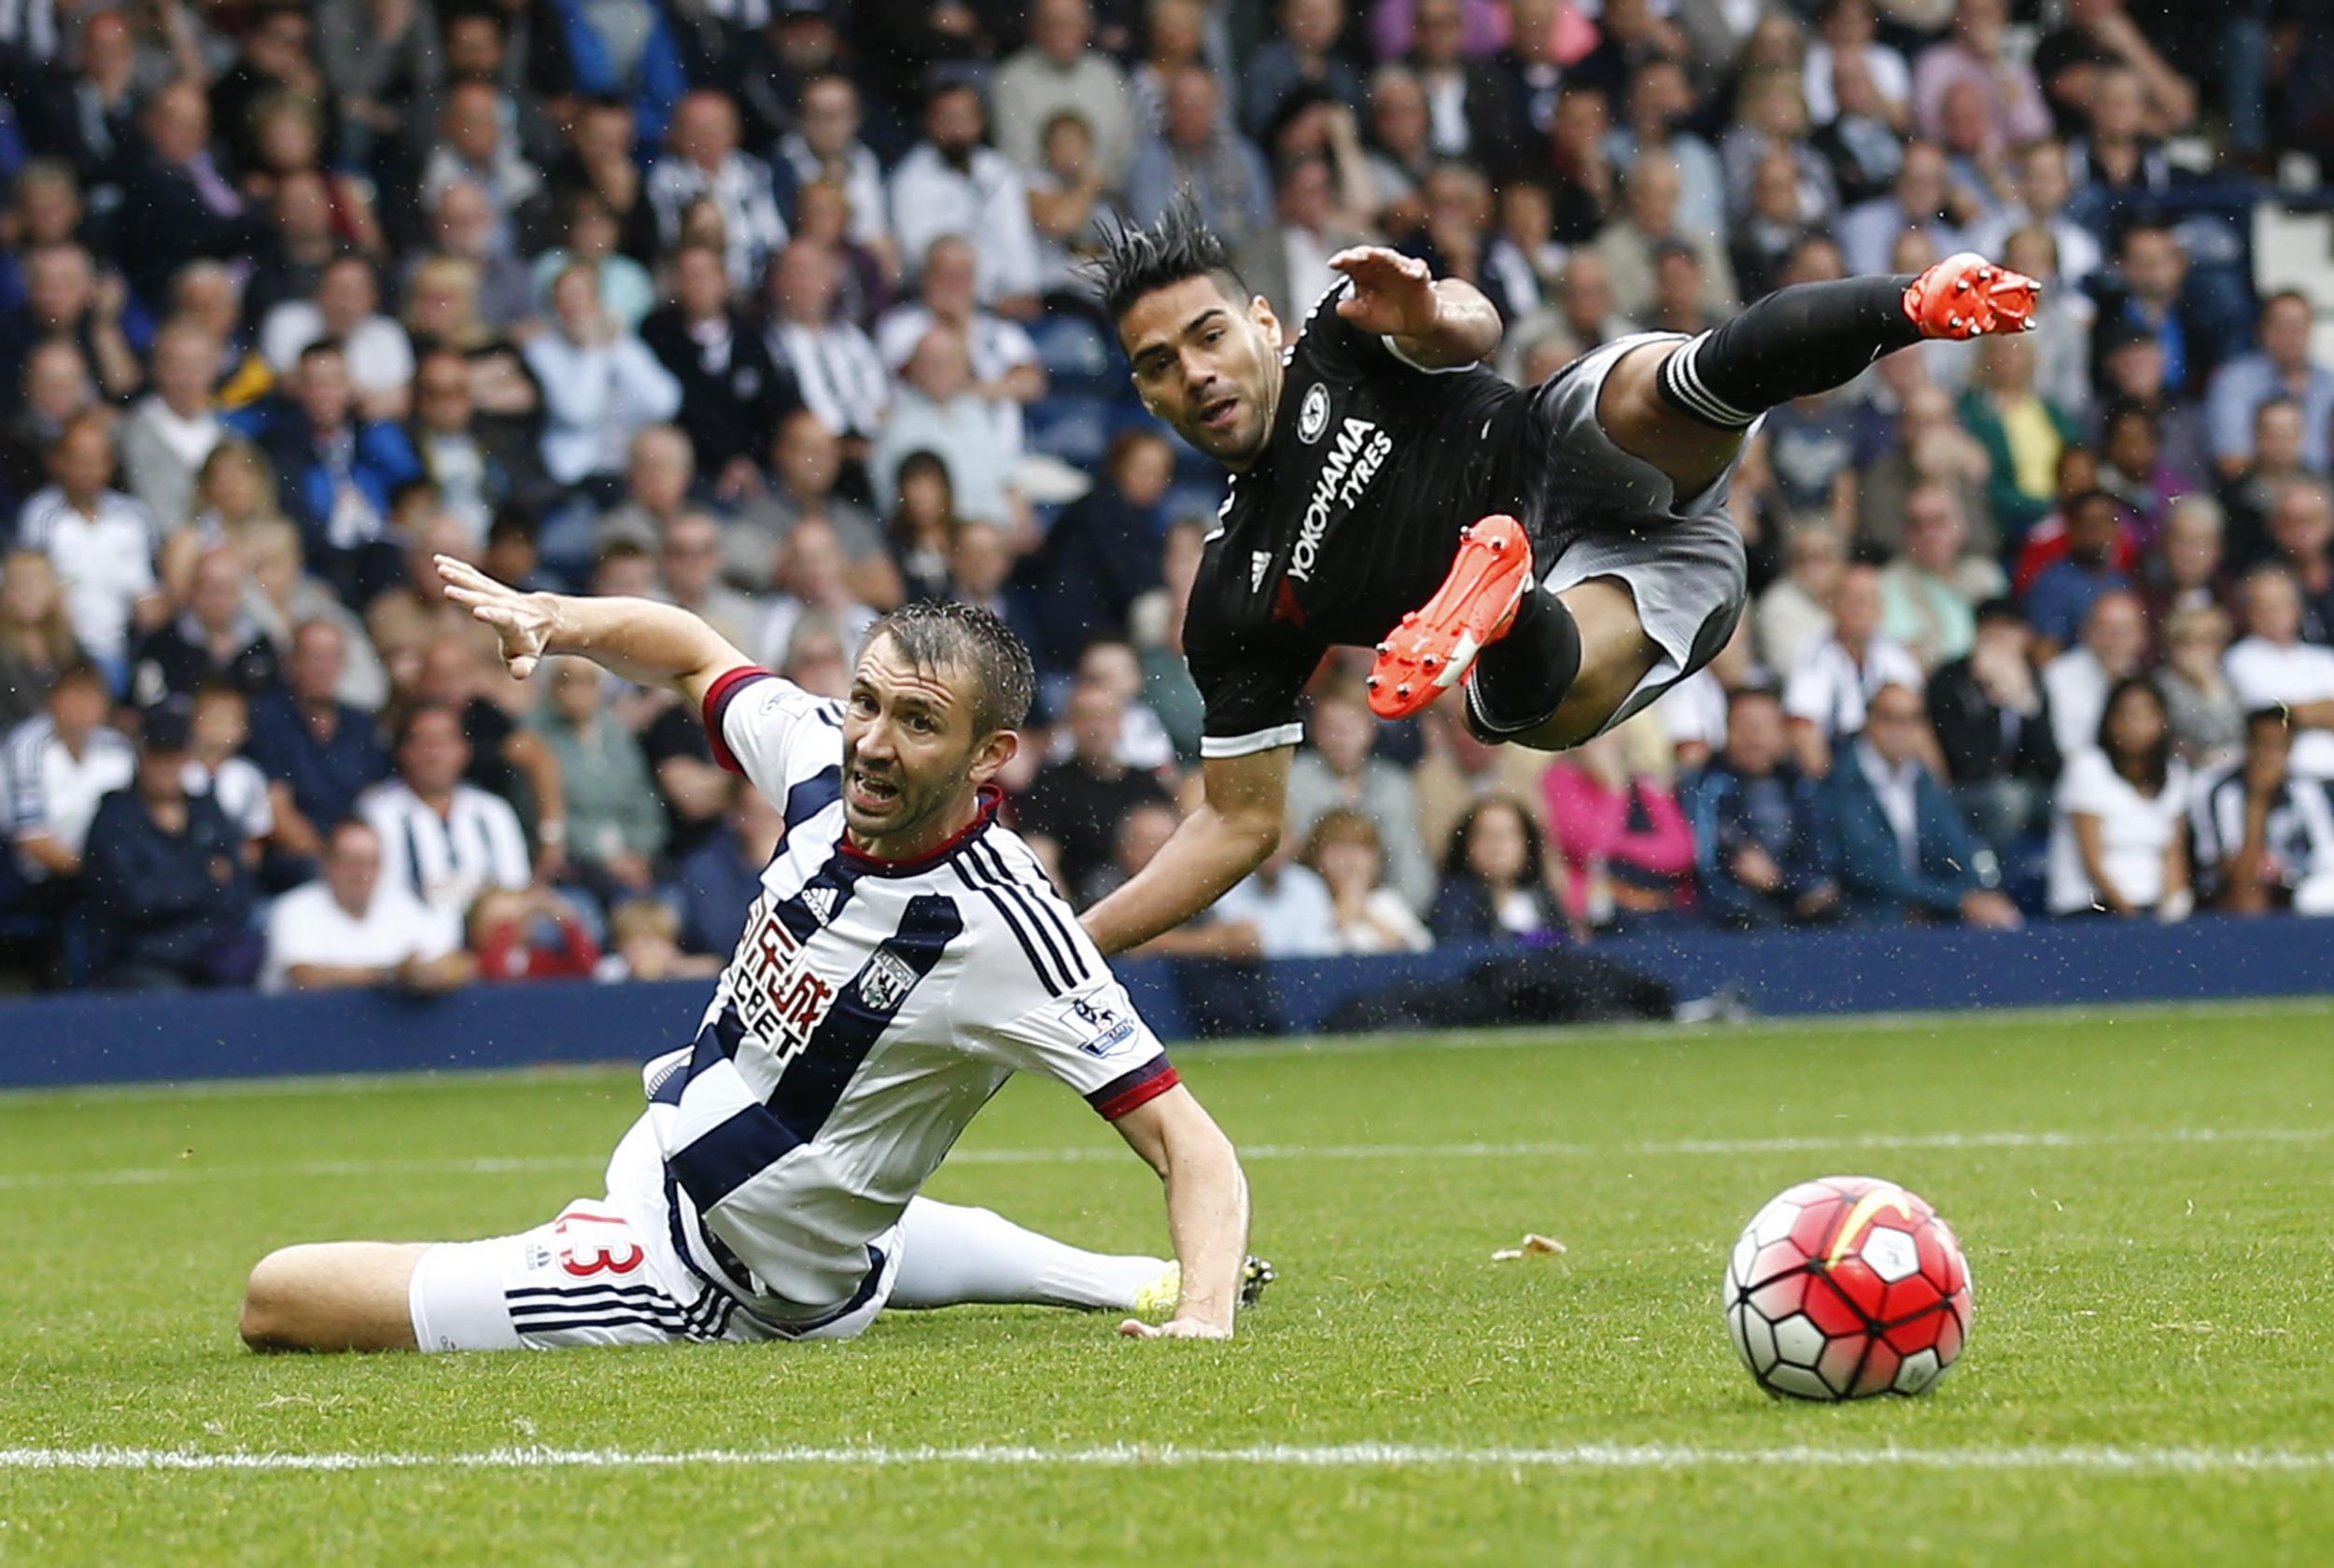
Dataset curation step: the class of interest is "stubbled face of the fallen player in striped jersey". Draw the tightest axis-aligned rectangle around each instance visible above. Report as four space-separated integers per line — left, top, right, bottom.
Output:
843 637 1013 857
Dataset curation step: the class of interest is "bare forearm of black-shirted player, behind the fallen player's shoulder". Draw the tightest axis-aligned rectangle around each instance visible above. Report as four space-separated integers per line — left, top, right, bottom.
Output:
1078 747 1296 955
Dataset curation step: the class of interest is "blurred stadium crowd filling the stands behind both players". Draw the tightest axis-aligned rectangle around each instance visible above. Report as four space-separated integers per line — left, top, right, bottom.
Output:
0 0 2334 992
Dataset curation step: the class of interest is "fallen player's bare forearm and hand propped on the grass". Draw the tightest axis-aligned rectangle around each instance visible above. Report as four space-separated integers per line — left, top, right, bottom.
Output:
1114 1085 1249 1339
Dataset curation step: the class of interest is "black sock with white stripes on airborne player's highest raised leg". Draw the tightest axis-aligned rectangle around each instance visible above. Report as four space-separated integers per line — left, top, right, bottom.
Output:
1662 275 1921 429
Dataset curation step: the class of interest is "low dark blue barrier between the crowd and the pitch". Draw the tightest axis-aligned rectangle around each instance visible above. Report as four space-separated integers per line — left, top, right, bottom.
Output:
0 917 2334 1087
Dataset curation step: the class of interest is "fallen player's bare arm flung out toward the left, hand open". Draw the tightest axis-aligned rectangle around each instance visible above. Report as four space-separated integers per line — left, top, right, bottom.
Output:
437 555 754 707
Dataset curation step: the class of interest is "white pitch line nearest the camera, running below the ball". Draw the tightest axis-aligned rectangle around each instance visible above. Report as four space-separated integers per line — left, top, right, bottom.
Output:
0 1442 2334 1475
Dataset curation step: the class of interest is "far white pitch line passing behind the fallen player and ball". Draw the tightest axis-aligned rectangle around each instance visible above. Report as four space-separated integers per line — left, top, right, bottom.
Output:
0 1127 2334 1193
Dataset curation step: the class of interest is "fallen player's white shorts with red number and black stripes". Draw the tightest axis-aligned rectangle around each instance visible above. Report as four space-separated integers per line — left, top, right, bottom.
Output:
406 1199 901 1351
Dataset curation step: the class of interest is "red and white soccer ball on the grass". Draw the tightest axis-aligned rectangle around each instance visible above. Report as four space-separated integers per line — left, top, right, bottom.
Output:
1727 1176 1970 1400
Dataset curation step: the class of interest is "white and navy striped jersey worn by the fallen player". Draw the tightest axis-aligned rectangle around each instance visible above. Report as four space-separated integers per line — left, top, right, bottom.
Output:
612 667 1176 1333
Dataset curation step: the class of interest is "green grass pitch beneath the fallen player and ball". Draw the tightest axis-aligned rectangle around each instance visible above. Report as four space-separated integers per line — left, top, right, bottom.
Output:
0 1006 2334 1568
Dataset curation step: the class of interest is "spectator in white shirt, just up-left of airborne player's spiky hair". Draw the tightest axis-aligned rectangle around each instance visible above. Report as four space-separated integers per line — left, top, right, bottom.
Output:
890 82 1039 315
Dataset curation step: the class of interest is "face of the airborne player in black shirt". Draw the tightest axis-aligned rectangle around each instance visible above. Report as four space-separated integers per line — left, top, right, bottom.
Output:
1118 278 1282 469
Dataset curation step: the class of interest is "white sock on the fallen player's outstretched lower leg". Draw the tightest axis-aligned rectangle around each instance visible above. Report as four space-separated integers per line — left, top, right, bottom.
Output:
892 1197 1167 1311
